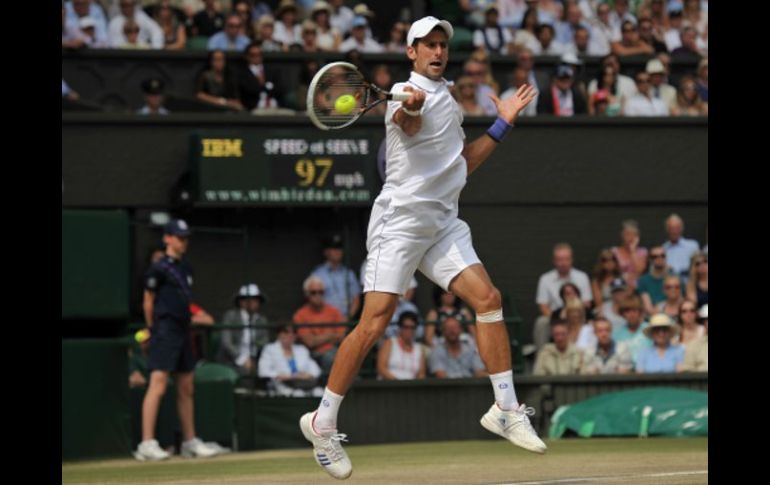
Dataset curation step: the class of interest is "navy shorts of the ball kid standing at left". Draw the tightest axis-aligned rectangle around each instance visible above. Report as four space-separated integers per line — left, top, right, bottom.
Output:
147 320 195 372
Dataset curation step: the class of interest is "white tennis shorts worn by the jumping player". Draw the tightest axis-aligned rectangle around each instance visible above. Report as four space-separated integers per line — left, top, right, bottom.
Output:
364 200 481 295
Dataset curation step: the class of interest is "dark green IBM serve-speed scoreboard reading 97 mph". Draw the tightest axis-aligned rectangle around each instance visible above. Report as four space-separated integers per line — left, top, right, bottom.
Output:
190 127 384 206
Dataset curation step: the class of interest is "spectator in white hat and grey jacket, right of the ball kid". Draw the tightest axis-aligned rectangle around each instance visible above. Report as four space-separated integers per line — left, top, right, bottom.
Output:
217 283 269 374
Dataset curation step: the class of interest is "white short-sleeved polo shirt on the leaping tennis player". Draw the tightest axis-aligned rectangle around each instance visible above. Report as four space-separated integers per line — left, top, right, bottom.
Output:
379 72 468 226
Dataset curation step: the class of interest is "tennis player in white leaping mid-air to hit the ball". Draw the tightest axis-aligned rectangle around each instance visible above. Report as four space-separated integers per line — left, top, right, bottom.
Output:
300 17 546 479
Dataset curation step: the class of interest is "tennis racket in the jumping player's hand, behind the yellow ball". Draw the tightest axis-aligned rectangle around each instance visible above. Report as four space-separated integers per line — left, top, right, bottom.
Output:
307 62 411 130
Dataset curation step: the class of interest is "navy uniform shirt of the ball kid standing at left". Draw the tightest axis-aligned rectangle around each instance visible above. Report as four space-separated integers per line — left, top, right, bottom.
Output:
144 255 193 323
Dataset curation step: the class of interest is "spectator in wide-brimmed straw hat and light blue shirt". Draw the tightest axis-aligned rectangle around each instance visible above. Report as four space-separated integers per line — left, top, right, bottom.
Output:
636 313 684 374
